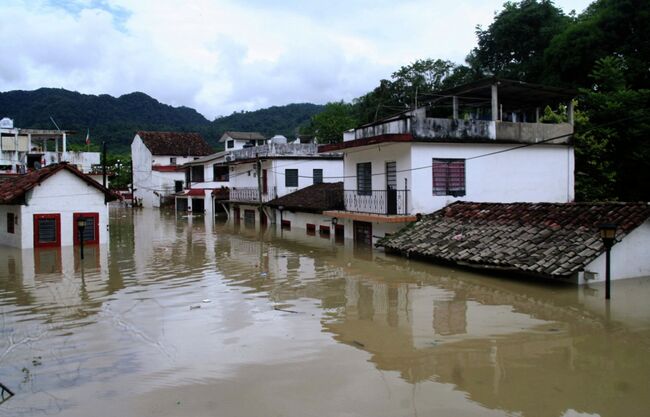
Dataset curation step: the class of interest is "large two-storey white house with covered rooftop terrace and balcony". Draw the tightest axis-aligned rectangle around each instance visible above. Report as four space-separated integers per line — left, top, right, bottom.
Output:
319 78 575 245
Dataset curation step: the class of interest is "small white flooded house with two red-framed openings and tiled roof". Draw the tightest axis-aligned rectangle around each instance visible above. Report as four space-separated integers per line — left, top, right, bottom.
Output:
0 163 119 249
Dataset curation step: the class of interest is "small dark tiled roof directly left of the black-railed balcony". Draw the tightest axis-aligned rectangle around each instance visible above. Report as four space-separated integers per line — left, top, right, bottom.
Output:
267 182 344 213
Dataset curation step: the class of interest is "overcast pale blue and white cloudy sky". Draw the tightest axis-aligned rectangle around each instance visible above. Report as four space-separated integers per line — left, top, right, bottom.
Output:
0 0 590 119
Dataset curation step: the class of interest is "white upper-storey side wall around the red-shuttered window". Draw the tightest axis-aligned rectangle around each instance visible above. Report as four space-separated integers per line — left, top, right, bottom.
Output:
410 143 574 214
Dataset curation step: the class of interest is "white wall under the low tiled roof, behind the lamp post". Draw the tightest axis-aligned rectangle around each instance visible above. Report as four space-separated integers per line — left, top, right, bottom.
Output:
579 220 650 284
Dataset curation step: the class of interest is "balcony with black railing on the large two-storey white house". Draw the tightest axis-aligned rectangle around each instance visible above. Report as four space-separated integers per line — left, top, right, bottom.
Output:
323 190 415 223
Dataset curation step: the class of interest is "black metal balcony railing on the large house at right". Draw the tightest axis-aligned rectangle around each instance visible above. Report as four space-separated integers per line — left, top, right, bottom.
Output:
343 190 410 215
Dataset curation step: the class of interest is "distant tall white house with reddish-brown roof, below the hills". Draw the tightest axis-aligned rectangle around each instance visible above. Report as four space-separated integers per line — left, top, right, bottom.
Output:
131 131 212 208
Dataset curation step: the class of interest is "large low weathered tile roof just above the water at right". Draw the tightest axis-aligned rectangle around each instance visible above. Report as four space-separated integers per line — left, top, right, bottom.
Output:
377 202 650 278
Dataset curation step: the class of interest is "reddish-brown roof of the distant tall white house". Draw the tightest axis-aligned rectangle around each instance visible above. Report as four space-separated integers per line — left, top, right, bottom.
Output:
137 131 214 156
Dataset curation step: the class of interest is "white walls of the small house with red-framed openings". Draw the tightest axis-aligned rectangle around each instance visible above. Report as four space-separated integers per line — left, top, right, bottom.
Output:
0 170 108 249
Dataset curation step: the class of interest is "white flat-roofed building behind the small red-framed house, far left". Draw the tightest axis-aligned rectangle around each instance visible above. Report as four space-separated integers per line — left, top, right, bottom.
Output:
0 117 100 174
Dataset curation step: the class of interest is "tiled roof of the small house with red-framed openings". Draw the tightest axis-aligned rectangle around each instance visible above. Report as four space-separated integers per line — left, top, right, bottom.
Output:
0 162 120 204
